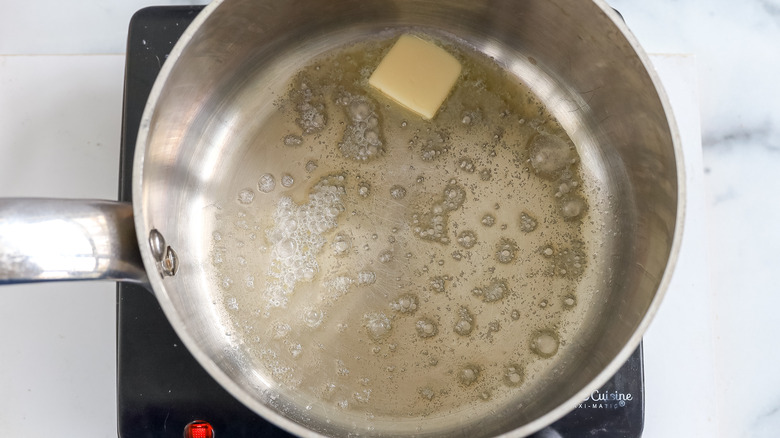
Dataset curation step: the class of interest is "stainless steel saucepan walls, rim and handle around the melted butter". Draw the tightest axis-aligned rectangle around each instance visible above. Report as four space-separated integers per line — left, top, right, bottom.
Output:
0 0 684 437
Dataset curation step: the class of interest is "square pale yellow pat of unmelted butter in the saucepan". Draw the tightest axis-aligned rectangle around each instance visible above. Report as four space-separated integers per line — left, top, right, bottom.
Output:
368 35 461 119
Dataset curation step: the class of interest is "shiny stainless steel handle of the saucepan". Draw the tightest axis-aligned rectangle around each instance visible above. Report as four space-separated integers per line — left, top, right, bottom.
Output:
0 198 148 284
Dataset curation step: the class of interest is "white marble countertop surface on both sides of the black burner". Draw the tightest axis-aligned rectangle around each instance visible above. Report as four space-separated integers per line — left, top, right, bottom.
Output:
0 0 780 438
